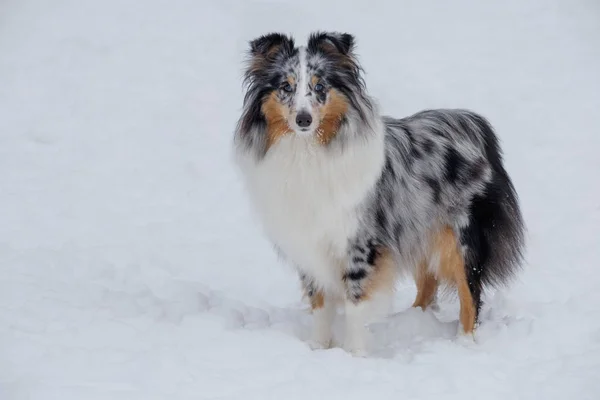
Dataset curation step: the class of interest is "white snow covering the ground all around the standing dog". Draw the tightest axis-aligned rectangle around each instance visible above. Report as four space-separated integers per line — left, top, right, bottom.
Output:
0 0 600 400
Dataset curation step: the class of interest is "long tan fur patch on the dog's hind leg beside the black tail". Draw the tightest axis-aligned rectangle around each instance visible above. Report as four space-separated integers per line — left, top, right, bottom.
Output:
432 227 475 333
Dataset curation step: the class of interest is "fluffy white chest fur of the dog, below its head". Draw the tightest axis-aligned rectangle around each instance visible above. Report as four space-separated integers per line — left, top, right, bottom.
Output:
236 134 384 292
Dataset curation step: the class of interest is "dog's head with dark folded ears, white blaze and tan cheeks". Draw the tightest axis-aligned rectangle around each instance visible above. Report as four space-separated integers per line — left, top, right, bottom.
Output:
241 32 371 145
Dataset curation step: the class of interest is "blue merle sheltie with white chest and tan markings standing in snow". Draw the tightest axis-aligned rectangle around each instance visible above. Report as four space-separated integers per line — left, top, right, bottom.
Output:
234 32 524 355
